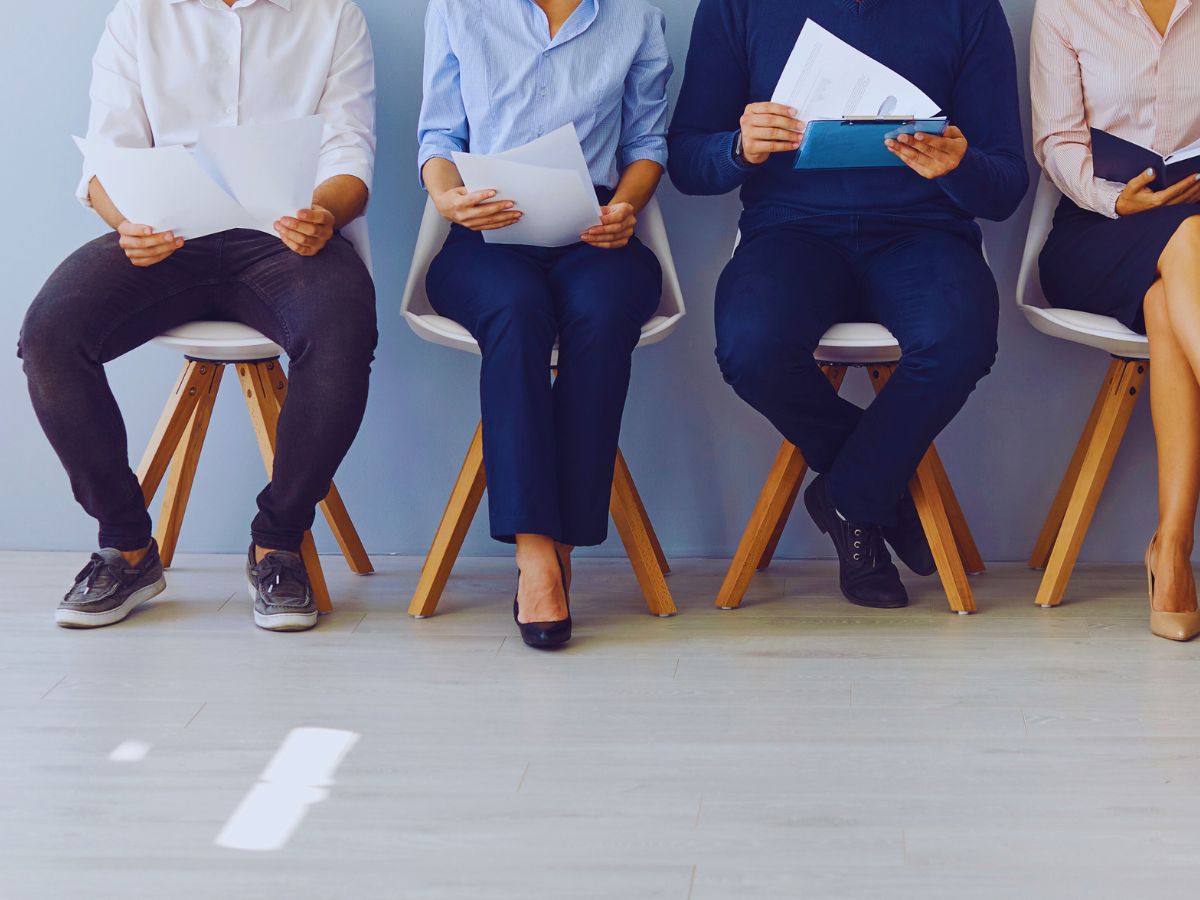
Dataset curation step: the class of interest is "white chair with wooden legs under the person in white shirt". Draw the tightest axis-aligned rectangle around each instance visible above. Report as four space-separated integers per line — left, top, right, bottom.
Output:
137 217 373 613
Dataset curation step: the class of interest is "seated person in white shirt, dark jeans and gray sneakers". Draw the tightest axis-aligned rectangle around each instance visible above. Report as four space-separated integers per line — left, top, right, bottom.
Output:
19 0 377 631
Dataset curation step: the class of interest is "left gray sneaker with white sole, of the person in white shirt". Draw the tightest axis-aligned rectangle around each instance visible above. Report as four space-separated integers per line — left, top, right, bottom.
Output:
54 540 167 628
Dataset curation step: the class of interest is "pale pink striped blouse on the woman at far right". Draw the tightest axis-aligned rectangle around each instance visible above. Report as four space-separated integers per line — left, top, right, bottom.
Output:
1030 0 1200 218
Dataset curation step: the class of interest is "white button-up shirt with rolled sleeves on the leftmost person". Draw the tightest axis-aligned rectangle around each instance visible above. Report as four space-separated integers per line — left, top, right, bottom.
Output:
77 0 376 206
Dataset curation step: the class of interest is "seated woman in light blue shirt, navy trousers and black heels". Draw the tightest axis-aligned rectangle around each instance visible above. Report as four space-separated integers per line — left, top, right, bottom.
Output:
419 0 671 647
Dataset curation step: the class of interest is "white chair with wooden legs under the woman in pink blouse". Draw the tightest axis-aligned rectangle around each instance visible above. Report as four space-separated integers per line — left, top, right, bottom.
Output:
1016 175 1150 608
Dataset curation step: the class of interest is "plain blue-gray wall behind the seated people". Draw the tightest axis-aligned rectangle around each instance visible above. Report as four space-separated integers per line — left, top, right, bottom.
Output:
0 0 1156 560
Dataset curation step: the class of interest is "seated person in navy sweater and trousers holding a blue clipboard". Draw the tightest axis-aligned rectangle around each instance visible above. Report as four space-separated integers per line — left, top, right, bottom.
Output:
667 0 1028 607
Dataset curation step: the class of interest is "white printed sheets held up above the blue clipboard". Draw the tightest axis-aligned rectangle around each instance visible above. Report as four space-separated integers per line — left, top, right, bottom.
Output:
770 19 938 122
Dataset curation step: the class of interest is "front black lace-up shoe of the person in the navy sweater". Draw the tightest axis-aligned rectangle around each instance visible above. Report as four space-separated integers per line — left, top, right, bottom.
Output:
804 474 908 610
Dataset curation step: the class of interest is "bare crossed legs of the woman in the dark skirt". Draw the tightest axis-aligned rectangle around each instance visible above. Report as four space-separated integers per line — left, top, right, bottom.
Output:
1145 216 1200 612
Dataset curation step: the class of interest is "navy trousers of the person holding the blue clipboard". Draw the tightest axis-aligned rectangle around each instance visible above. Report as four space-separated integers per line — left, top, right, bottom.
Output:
716 216 1000 526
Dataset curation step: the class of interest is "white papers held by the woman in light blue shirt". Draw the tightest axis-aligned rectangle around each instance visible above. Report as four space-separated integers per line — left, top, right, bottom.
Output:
454 125 600 247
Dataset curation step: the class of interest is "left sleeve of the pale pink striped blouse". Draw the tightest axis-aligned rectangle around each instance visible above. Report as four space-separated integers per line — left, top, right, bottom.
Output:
1030 4 1124 218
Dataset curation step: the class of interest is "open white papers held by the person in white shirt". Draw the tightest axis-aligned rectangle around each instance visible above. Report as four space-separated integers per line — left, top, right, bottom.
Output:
74 115 325 240
